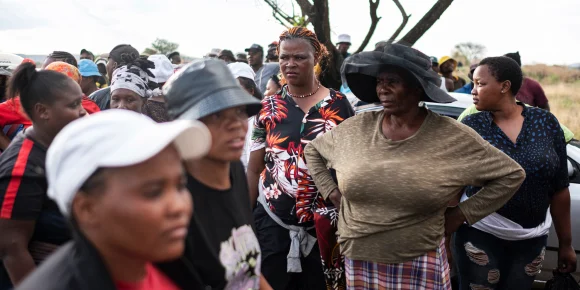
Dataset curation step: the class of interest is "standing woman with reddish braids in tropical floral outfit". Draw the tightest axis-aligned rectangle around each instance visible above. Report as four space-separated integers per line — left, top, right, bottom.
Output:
247 27 354 289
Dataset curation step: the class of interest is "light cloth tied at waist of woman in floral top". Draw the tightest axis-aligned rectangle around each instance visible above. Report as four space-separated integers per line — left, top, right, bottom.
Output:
258 178 316 273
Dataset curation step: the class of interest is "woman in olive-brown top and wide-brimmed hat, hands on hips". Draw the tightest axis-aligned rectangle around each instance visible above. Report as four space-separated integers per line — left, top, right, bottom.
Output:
305 44 524 289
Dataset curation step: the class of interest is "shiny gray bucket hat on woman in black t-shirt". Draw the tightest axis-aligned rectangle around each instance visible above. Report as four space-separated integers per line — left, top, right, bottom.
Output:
163 59 262 120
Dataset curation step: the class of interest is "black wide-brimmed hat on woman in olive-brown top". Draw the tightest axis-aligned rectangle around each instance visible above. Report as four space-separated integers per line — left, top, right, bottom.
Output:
340 43 456 103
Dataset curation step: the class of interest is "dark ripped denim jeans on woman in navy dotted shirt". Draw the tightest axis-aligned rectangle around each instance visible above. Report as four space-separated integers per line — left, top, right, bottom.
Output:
453 225 548 290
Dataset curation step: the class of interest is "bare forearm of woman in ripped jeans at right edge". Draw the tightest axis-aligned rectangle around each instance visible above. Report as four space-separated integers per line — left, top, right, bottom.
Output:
550 188 572 247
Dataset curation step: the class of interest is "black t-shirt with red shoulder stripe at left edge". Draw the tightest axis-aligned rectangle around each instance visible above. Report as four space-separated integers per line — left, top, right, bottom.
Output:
0 133 71 290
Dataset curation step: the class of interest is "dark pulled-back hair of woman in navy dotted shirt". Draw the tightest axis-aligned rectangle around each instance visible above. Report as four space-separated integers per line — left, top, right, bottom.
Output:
479 56 524 96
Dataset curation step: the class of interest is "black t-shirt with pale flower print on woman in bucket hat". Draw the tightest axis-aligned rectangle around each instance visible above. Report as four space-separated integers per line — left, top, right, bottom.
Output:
187 161 261 289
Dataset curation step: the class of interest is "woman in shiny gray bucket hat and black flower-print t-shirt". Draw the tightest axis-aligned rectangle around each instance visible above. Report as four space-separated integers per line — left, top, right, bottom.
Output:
163 59 272 289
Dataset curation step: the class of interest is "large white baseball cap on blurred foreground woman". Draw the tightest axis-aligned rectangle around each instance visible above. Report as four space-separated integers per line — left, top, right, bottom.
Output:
46 110 211 216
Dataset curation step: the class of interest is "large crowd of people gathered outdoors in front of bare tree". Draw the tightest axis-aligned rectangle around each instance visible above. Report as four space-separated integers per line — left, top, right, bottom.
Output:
0 27 576 290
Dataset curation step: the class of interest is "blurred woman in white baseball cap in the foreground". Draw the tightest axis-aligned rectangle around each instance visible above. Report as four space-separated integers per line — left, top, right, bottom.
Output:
16 110 211 290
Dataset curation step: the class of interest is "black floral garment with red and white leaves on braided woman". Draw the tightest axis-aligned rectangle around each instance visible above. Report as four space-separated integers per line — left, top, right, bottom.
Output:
251 86 354 289
